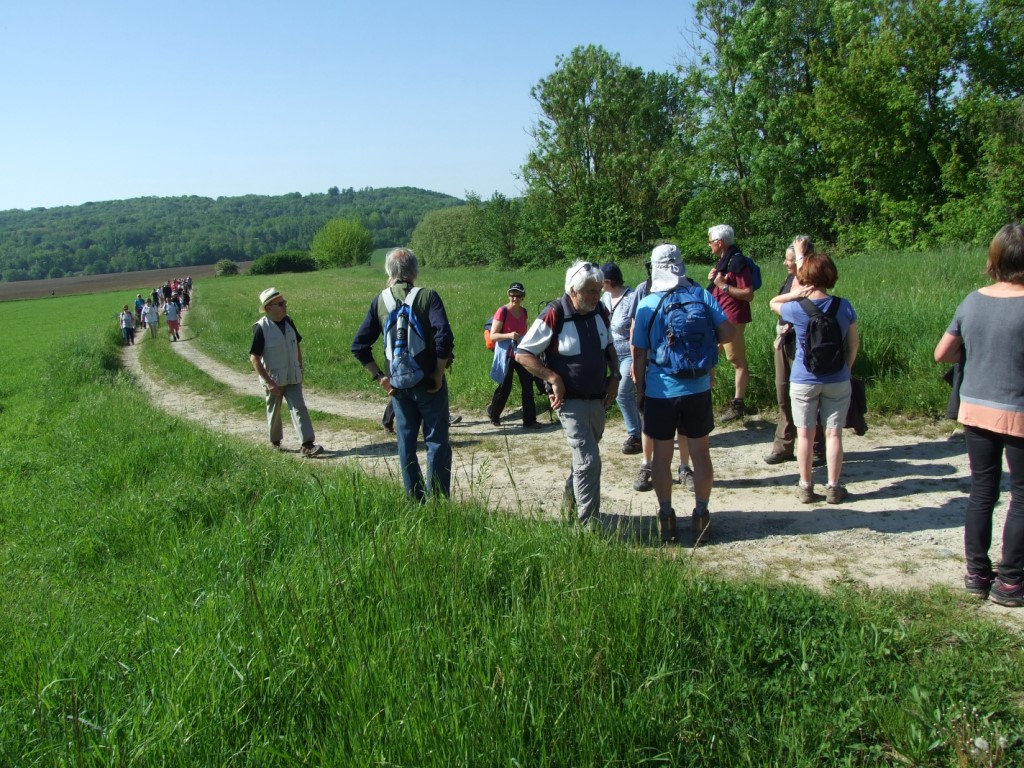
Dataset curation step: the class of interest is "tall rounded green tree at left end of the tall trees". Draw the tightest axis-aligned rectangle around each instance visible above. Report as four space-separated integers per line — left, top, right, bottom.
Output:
522 45 684 260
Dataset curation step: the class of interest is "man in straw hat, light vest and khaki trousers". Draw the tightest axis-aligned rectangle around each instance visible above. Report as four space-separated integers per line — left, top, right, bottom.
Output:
245 288 324 458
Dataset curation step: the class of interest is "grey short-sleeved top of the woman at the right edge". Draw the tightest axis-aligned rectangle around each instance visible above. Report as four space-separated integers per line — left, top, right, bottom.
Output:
946 291 1024 413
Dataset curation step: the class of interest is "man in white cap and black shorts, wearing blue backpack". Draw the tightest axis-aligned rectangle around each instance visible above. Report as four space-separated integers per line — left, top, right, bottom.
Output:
631 243 735 544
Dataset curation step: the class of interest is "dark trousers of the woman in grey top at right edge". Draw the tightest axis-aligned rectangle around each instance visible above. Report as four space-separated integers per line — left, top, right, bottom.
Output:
964 426 1024 584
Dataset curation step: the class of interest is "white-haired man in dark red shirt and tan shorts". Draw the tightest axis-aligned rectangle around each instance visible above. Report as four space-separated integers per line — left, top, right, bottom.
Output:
708 224 755 424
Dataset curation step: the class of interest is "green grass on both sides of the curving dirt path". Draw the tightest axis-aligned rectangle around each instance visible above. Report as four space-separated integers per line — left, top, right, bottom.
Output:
0 254 1024 766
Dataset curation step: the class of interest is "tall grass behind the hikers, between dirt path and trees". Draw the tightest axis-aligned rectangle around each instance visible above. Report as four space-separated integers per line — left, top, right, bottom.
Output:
180 250 985 417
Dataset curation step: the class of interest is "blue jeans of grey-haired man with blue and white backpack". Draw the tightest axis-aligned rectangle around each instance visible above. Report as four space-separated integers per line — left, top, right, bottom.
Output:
391 378 452 502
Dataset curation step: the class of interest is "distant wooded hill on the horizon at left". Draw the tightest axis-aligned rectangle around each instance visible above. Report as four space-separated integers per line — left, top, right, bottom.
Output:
0 186 463 282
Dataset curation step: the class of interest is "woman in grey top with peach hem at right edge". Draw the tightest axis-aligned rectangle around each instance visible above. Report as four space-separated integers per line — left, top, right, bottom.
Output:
935 224 1024 608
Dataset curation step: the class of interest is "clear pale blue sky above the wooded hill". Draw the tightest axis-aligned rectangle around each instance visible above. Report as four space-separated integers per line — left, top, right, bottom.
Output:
0 0 693 210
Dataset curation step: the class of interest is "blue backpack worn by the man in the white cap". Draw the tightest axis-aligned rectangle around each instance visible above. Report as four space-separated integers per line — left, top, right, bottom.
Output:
647 282 718 379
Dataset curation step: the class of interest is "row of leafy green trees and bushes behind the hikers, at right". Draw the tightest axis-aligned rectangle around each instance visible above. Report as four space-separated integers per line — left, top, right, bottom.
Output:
413 0 1024 266
